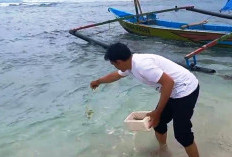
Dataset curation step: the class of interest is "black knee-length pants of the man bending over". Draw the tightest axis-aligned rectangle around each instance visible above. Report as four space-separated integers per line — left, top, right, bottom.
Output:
154 85 199 146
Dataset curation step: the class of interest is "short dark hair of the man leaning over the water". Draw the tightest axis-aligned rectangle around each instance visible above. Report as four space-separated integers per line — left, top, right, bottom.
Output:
104 43 131 62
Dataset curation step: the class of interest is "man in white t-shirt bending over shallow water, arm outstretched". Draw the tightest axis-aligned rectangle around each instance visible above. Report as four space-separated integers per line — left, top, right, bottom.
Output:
90 43 199 157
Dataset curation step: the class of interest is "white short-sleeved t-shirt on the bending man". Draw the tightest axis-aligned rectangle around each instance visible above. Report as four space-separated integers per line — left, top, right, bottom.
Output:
118 54 198 98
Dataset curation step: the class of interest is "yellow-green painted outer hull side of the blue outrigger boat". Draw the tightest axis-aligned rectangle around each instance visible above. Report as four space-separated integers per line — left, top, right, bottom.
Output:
109 7 232 46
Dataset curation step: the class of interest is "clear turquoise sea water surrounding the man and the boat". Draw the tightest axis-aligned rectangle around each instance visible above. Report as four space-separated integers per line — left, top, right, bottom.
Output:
0 0 232 157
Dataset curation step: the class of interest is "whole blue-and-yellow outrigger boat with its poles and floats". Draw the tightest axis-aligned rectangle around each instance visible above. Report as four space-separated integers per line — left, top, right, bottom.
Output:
69 0 232 77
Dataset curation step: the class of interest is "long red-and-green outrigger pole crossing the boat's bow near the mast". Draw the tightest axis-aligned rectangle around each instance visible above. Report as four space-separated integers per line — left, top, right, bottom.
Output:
69 6 194 33
